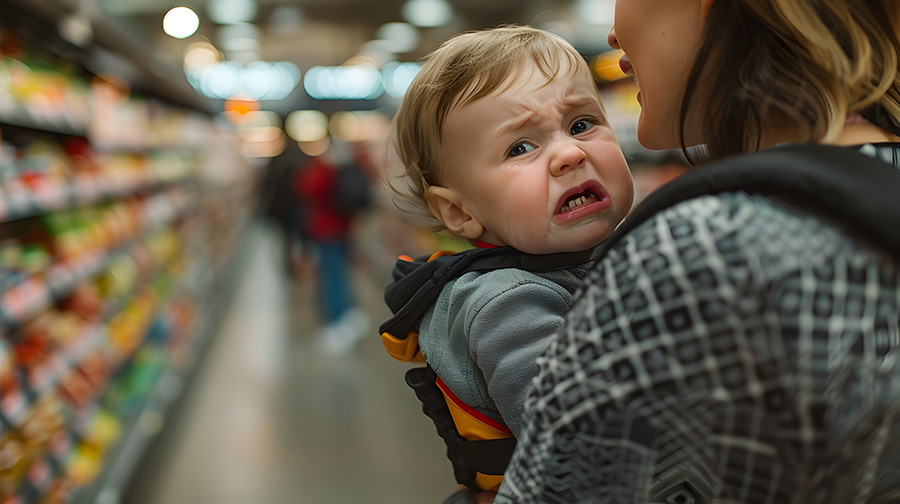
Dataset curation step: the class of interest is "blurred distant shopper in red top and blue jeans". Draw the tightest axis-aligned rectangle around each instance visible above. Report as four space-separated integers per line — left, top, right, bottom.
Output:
294 142 369 354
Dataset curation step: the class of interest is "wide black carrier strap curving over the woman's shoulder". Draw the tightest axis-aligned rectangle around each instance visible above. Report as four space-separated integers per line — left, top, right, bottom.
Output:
593 144 900 259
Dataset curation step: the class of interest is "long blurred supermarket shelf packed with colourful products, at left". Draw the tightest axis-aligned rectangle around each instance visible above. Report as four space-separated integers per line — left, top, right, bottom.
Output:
0 4 256 504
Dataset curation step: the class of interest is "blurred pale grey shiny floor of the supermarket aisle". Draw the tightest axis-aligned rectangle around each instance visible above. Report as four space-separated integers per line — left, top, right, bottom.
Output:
126 224 455 504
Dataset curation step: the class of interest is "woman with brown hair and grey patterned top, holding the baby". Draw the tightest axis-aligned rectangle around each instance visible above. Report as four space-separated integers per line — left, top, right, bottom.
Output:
495 0 900 503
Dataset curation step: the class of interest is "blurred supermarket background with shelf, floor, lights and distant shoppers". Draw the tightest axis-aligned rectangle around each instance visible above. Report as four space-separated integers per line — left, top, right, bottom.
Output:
0 0 685 504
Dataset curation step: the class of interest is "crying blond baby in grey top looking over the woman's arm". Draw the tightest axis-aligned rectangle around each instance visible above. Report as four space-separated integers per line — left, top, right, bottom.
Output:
383 26 634 490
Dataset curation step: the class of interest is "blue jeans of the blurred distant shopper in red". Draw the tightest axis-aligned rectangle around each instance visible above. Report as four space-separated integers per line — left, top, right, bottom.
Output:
317 240 353 324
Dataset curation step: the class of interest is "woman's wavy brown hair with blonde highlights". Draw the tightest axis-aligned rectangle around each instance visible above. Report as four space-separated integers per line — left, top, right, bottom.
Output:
680 0 900 159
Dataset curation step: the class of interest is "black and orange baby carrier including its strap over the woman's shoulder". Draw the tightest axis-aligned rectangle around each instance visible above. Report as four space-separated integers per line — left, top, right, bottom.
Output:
379 144 900 490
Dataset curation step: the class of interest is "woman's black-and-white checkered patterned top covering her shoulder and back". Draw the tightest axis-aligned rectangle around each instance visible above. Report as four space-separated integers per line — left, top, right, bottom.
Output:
495 146 900 504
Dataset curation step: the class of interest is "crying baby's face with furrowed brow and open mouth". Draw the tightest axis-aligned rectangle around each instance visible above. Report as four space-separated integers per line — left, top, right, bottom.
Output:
443 63 634 254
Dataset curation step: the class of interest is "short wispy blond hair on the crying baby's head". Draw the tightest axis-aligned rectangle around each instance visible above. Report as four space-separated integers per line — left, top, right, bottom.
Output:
389 26 590 230
